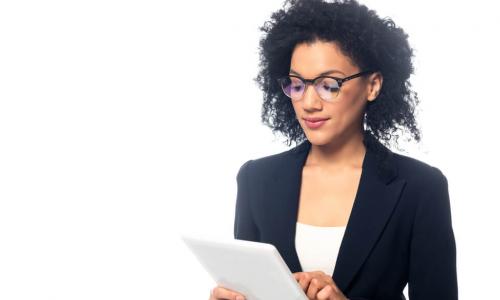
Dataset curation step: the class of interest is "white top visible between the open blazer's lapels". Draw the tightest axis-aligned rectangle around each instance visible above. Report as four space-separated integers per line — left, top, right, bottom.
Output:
295 222 346 276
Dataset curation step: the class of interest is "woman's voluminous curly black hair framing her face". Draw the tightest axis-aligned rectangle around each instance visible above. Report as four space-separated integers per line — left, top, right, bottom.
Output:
254 0 420 146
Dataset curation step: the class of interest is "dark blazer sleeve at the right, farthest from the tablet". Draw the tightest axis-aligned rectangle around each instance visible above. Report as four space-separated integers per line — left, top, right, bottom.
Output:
408 167 458 300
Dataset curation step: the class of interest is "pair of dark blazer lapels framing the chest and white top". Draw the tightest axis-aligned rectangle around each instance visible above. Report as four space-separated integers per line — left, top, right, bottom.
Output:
266 132 405 291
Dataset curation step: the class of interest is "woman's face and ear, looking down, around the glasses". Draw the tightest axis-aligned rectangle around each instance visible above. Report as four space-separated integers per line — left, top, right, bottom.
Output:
290 41 381 145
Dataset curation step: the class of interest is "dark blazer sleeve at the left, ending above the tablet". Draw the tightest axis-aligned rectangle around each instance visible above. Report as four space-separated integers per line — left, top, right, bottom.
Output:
234 160 259 242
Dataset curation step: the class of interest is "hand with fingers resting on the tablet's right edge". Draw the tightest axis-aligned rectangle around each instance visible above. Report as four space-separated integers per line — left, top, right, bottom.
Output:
293 271 348 300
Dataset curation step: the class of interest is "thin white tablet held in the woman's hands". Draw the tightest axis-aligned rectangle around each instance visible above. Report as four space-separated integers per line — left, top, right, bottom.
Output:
181 235 308 300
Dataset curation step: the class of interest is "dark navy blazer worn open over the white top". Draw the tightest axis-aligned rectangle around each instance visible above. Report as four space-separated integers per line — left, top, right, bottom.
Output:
234 134 458 300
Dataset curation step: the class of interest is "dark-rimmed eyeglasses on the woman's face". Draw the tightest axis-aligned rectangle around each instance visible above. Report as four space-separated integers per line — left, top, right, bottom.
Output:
278 70 375 102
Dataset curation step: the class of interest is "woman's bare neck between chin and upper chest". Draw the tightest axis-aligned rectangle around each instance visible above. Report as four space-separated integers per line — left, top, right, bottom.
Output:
306 131 366 169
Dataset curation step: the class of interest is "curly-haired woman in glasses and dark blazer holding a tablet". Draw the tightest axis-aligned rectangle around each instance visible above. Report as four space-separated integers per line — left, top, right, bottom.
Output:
210 0 458 300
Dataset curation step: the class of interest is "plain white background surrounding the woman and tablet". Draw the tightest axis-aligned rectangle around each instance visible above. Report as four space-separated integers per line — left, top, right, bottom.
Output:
0 0 500 299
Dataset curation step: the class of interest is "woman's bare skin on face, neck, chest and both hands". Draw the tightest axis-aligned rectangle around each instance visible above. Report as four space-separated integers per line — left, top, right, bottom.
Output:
209 40 383 300
